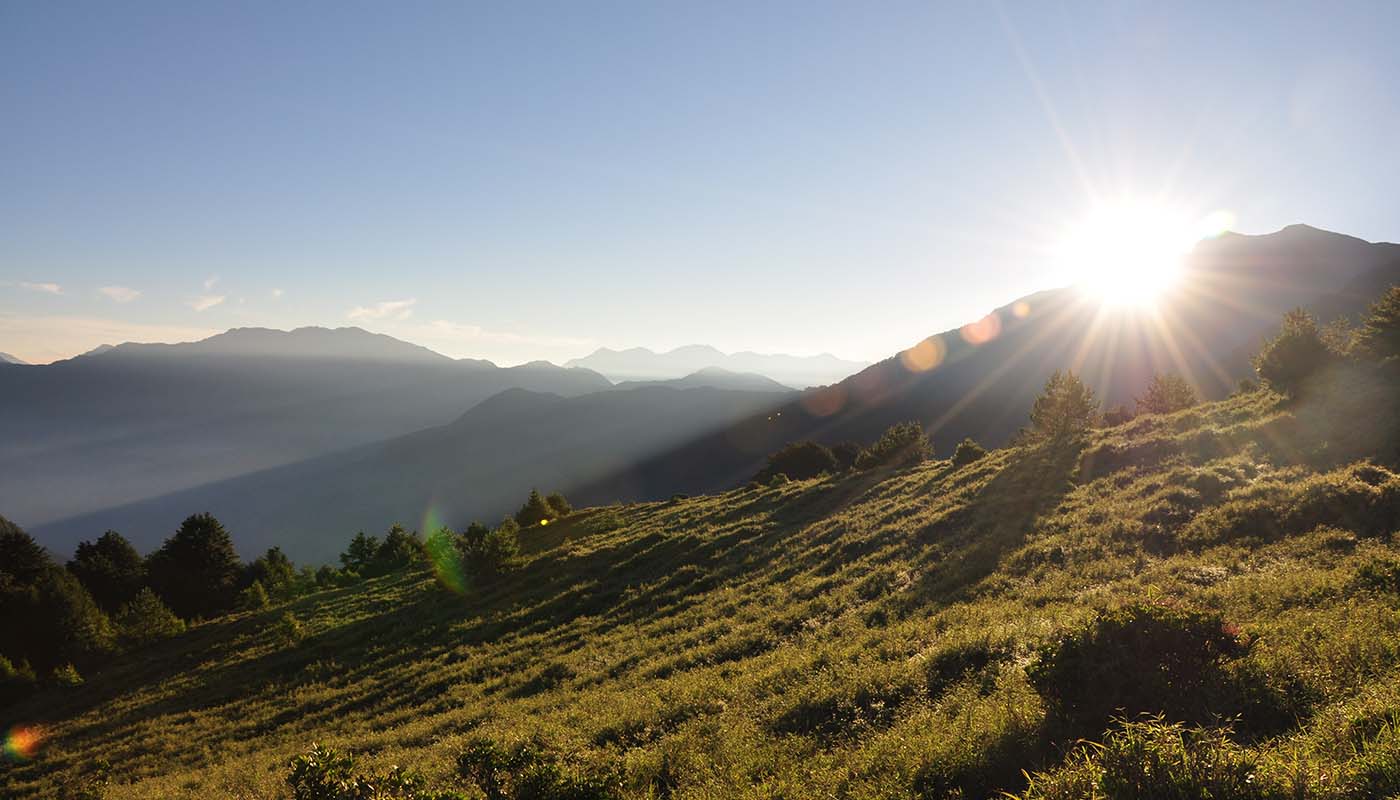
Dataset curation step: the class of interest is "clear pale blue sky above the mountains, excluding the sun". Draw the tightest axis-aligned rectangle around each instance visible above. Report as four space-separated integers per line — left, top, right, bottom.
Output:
0 0 1400 363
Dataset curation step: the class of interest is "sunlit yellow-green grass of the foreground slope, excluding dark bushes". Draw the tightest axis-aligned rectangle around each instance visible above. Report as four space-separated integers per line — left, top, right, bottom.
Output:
0 392 1400 797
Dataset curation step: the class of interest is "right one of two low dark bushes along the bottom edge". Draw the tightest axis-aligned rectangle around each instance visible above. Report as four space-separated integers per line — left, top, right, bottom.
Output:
456 738 622 800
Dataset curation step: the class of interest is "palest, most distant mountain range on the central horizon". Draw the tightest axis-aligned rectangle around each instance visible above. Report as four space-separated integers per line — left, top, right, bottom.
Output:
564 345 867 388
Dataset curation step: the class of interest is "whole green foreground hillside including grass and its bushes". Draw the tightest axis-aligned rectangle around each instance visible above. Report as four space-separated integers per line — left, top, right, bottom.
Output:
8 295 1400 800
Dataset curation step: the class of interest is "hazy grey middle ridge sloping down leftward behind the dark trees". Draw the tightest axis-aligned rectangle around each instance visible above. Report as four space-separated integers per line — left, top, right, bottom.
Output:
32 383 774 563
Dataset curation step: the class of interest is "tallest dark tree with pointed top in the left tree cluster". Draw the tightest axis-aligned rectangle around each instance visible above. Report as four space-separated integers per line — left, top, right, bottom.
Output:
147 513 242 619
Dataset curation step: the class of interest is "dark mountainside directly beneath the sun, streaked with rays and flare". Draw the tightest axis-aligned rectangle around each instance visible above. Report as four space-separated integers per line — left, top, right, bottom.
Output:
573 226 1400 502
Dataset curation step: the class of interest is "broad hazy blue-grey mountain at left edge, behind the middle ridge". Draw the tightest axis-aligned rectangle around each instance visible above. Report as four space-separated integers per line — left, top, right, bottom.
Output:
0 328 612 525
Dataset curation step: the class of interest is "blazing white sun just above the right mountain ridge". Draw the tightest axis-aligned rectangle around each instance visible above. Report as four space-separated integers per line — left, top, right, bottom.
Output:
1058 199 1232 307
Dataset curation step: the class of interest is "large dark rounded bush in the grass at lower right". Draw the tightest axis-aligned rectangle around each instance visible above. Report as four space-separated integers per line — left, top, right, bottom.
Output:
1028 604 1247 737
